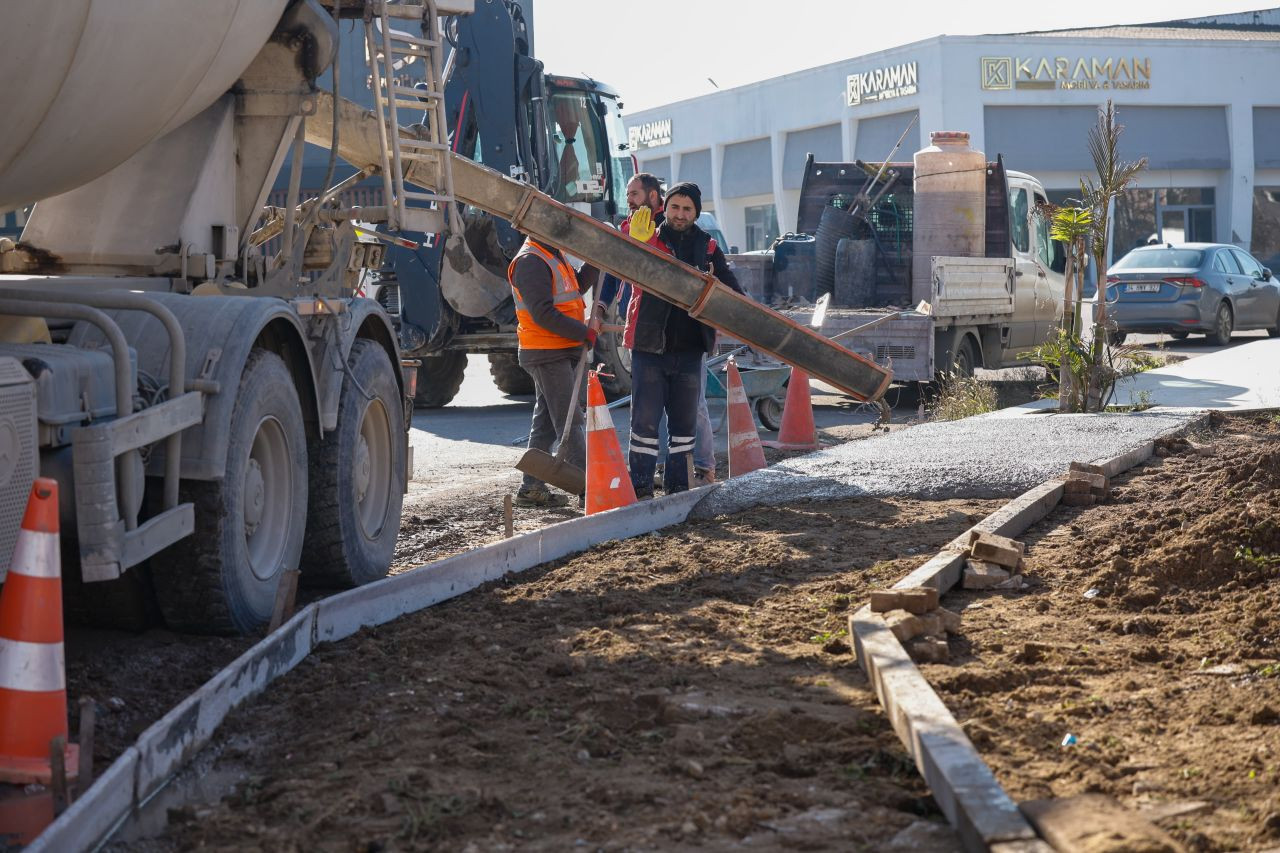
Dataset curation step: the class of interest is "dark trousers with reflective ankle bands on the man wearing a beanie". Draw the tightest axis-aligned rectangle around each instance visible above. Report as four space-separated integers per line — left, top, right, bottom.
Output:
627 351 703 494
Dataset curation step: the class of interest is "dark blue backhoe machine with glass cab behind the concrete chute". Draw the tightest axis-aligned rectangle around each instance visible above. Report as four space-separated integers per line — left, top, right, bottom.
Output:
348 0 635 409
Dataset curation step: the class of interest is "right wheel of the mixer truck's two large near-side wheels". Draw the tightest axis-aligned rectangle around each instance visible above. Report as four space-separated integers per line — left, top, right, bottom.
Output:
302 339 404 587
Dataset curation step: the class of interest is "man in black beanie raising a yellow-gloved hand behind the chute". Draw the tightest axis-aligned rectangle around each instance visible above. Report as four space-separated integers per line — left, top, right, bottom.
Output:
623 183 742 498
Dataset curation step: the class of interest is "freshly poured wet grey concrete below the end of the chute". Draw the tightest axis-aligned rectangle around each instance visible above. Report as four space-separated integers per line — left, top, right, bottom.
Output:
691 412 1196 517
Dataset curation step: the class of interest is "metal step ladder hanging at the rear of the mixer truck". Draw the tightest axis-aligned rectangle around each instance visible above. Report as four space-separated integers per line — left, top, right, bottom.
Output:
365 0 462 234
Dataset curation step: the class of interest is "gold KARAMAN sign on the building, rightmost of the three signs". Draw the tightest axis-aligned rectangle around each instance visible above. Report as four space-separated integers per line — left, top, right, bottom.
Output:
982 56 1151 91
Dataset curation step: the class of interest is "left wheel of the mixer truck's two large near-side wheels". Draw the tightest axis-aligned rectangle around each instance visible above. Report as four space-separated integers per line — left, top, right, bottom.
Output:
151 348 307 634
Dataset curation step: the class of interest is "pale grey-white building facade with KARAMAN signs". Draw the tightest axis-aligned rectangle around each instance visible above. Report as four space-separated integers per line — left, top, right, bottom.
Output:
625 9 1280 263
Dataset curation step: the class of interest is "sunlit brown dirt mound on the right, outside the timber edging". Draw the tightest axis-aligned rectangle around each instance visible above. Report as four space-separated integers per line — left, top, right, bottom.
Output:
923 416 1280 850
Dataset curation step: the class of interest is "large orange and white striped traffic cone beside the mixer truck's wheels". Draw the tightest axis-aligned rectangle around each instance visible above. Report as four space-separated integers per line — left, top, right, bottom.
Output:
0 478 79 785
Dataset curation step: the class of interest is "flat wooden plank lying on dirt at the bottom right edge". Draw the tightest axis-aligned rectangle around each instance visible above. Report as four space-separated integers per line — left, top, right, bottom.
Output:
1020 794 1185 853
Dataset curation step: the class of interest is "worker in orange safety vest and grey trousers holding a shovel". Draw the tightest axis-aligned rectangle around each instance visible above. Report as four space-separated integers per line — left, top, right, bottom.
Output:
507 237 600 507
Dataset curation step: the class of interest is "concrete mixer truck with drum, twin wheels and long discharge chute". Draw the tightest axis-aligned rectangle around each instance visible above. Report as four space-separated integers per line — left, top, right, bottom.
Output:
0 0 891 634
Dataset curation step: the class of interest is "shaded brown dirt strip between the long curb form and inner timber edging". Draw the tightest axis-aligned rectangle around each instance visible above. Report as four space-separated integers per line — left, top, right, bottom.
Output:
117 498 997 850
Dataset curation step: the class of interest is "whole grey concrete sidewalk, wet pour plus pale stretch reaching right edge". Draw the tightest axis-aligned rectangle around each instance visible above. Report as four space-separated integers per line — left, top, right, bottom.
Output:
692 339 1280 517
